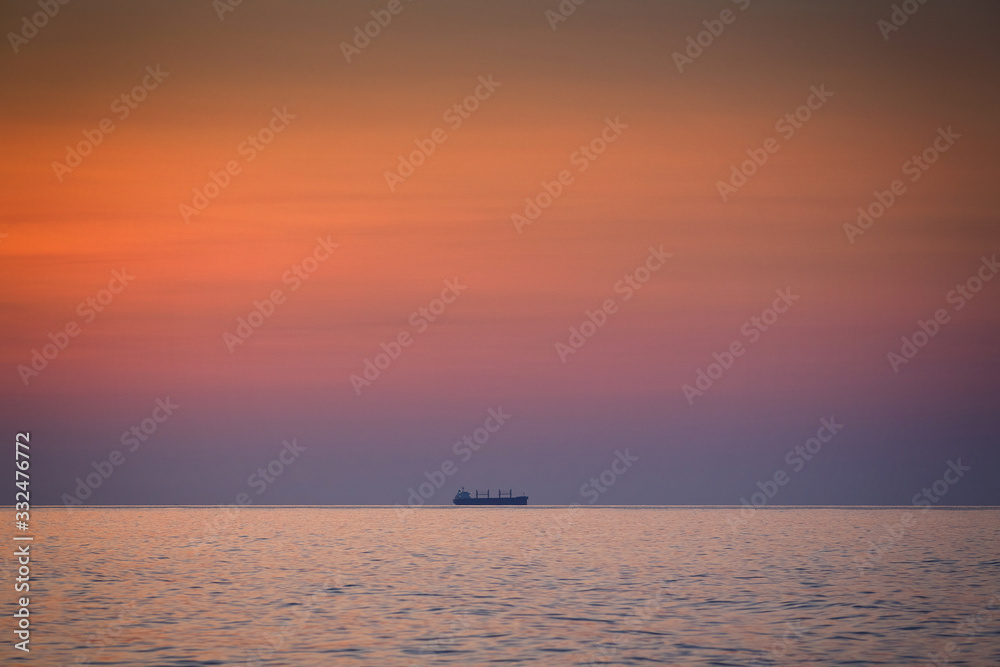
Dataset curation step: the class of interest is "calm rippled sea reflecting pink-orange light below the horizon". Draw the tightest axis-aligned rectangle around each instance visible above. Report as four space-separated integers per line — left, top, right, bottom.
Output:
9 506 1000 667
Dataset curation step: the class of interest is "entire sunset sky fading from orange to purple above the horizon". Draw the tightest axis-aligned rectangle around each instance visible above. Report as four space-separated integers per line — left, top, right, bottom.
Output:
0 0 1000 505
